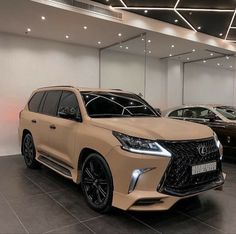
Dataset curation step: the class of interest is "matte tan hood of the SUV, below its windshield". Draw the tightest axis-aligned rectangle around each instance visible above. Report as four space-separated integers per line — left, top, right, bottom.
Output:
91 117 213 140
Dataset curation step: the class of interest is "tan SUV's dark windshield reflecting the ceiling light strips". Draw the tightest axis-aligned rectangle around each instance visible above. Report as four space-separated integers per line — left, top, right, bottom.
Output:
81 91 159 118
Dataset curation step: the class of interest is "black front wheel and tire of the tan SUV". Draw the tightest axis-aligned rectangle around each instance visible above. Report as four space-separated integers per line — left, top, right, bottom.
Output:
81 153 113 213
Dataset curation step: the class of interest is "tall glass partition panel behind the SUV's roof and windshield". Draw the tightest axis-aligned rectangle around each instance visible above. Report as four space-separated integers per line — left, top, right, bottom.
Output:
100 34 146 97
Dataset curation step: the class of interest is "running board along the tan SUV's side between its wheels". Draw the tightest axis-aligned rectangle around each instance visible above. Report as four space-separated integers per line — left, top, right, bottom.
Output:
38 155 72 178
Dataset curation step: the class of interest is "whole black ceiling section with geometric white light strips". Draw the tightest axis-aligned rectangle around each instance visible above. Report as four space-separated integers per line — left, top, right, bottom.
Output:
93 0 236 41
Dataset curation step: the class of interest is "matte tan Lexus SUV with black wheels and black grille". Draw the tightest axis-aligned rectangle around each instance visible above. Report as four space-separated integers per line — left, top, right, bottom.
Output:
19 86 224 212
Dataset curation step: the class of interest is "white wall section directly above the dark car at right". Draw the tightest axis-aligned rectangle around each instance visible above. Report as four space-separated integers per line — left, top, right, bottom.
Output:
184 63 236 105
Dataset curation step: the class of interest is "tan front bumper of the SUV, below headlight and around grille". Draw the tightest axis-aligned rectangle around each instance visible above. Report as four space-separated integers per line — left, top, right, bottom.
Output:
107 146 224 211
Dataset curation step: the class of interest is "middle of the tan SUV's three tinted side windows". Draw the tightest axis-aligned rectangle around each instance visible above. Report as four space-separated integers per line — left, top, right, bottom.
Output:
42 90 62 116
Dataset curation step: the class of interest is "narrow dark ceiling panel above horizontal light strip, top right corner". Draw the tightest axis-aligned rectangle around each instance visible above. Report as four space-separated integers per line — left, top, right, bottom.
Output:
178 0 236 10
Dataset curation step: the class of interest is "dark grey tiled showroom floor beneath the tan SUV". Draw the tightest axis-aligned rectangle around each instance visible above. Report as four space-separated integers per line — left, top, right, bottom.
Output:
0 156 236 234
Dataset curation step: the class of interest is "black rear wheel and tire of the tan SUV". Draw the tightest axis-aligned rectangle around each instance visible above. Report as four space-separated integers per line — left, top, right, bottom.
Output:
22 133 40 169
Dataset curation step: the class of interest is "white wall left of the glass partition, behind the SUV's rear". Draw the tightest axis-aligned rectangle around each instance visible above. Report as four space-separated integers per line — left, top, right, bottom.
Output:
0 33 99 155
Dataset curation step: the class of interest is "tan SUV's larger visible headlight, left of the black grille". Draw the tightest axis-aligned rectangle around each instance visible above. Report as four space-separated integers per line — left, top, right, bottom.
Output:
113 131 171 157
